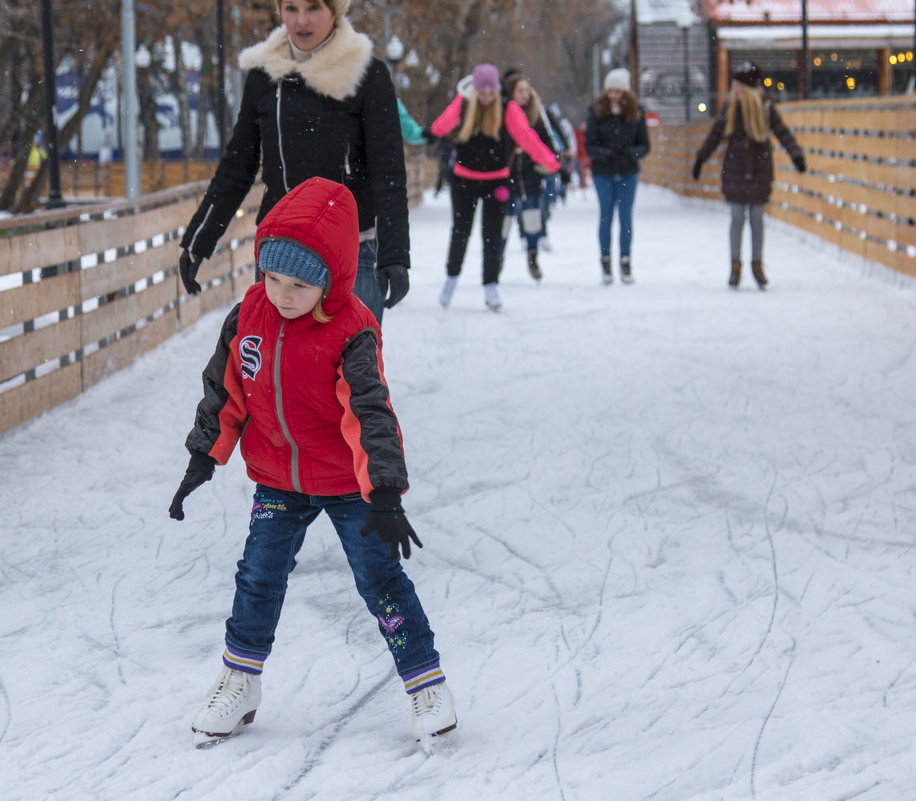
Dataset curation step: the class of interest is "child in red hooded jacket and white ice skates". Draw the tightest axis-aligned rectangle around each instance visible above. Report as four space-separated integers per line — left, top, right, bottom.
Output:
169 178 456 746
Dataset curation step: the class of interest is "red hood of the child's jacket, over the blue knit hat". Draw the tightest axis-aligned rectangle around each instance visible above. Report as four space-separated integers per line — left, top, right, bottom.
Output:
254 177 359 315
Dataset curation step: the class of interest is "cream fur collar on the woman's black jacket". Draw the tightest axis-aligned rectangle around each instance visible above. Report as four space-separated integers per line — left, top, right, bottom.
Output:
239 17 372 100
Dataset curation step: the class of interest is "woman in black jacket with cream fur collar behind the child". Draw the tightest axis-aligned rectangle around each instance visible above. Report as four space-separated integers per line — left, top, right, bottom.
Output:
180 0 410 322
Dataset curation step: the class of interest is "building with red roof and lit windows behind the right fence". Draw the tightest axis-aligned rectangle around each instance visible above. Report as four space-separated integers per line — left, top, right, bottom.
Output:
630 0 916 121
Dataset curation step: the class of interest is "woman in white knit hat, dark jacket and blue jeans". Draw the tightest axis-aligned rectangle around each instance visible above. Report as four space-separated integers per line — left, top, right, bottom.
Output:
585 69 649 284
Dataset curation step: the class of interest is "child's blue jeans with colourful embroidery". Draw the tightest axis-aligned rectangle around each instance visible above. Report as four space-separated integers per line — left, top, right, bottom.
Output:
226 484 439 677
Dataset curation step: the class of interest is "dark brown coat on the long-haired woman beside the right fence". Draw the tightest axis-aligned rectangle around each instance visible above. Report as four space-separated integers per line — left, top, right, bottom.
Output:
697 94 802 205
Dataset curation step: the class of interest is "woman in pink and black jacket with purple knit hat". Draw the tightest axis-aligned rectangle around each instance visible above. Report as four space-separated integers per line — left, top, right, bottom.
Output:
432 64 560 311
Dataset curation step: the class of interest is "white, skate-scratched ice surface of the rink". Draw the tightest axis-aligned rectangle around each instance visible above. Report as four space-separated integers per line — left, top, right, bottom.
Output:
0 185 916 801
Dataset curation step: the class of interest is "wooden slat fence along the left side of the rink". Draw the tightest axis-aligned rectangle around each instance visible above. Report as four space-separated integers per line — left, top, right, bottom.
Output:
0 159 436 433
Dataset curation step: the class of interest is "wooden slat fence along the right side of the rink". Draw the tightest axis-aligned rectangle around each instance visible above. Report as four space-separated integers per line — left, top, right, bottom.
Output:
642 95 916 276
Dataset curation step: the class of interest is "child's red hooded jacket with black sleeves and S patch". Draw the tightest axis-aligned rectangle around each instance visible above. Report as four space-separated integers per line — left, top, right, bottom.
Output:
186 178 407 500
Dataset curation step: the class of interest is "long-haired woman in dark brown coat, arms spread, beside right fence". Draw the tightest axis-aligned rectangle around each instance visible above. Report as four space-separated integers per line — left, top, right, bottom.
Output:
693 61 805 289
